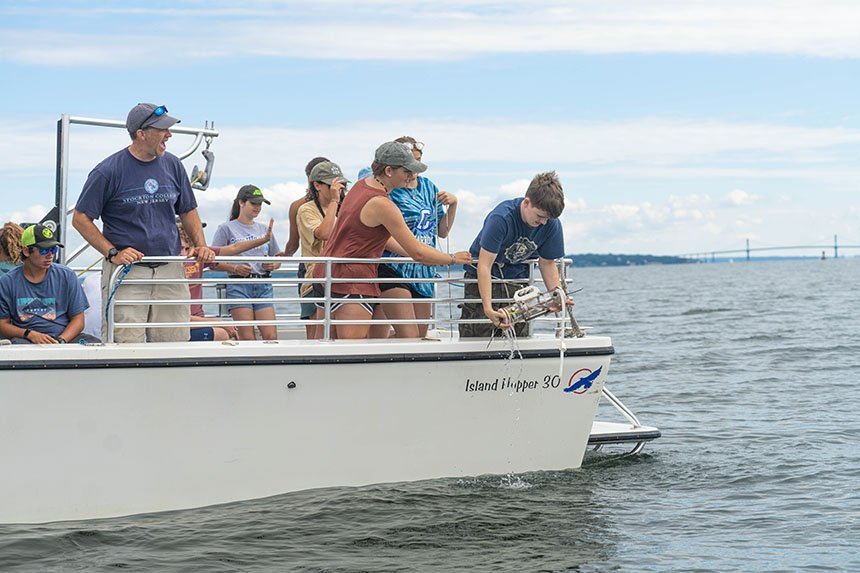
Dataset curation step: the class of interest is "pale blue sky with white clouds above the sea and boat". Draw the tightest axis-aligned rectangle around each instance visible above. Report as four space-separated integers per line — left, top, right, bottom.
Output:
0 0 860 255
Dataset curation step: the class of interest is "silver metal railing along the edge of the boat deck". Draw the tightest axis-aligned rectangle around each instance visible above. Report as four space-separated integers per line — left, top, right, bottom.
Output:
102 256 572 342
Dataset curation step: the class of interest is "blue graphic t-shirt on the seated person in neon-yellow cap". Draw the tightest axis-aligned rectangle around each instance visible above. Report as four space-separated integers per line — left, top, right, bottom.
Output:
0 263 90 338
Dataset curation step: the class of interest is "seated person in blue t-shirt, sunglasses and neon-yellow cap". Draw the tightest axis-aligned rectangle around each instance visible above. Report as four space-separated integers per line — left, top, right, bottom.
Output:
0 225 98 344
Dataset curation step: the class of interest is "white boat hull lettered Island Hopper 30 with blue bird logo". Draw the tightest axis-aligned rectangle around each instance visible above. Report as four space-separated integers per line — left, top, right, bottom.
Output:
0 111 659 523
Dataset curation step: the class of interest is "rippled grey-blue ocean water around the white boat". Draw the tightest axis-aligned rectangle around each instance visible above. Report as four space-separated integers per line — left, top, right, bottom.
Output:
0 259 860 572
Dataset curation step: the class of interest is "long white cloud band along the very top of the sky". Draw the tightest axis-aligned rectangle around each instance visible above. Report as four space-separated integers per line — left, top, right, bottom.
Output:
5 0 860 66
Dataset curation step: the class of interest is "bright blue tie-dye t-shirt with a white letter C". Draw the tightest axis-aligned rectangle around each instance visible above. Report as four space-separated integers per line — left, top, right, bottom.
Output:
382 176 445 297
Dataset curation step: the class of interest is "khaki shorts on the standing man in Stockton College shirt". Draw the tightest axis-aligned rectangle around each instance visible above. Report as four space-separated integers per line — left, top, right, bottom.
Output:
102 261 191 342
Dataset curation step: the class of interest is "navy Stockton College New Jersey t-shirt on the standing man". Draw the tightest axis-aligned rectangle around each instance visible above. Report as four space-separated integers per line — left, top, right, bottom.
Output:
75 148 197 256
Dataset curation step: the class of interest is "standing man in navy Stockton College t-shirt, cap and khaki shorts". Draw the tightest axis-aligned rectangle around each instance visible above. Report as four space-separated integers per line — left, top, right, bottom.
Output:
72 103 215 342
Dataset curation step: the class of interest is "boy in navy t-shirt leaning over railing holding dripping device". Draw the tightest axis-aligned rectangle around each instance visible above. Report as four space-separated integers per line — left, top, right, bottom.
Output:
459 171 564 338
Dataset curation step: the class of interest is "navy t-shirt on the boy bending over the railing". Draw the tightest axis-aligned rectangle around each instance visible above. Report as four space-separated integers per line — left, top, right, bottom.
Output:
464 197 564 279
